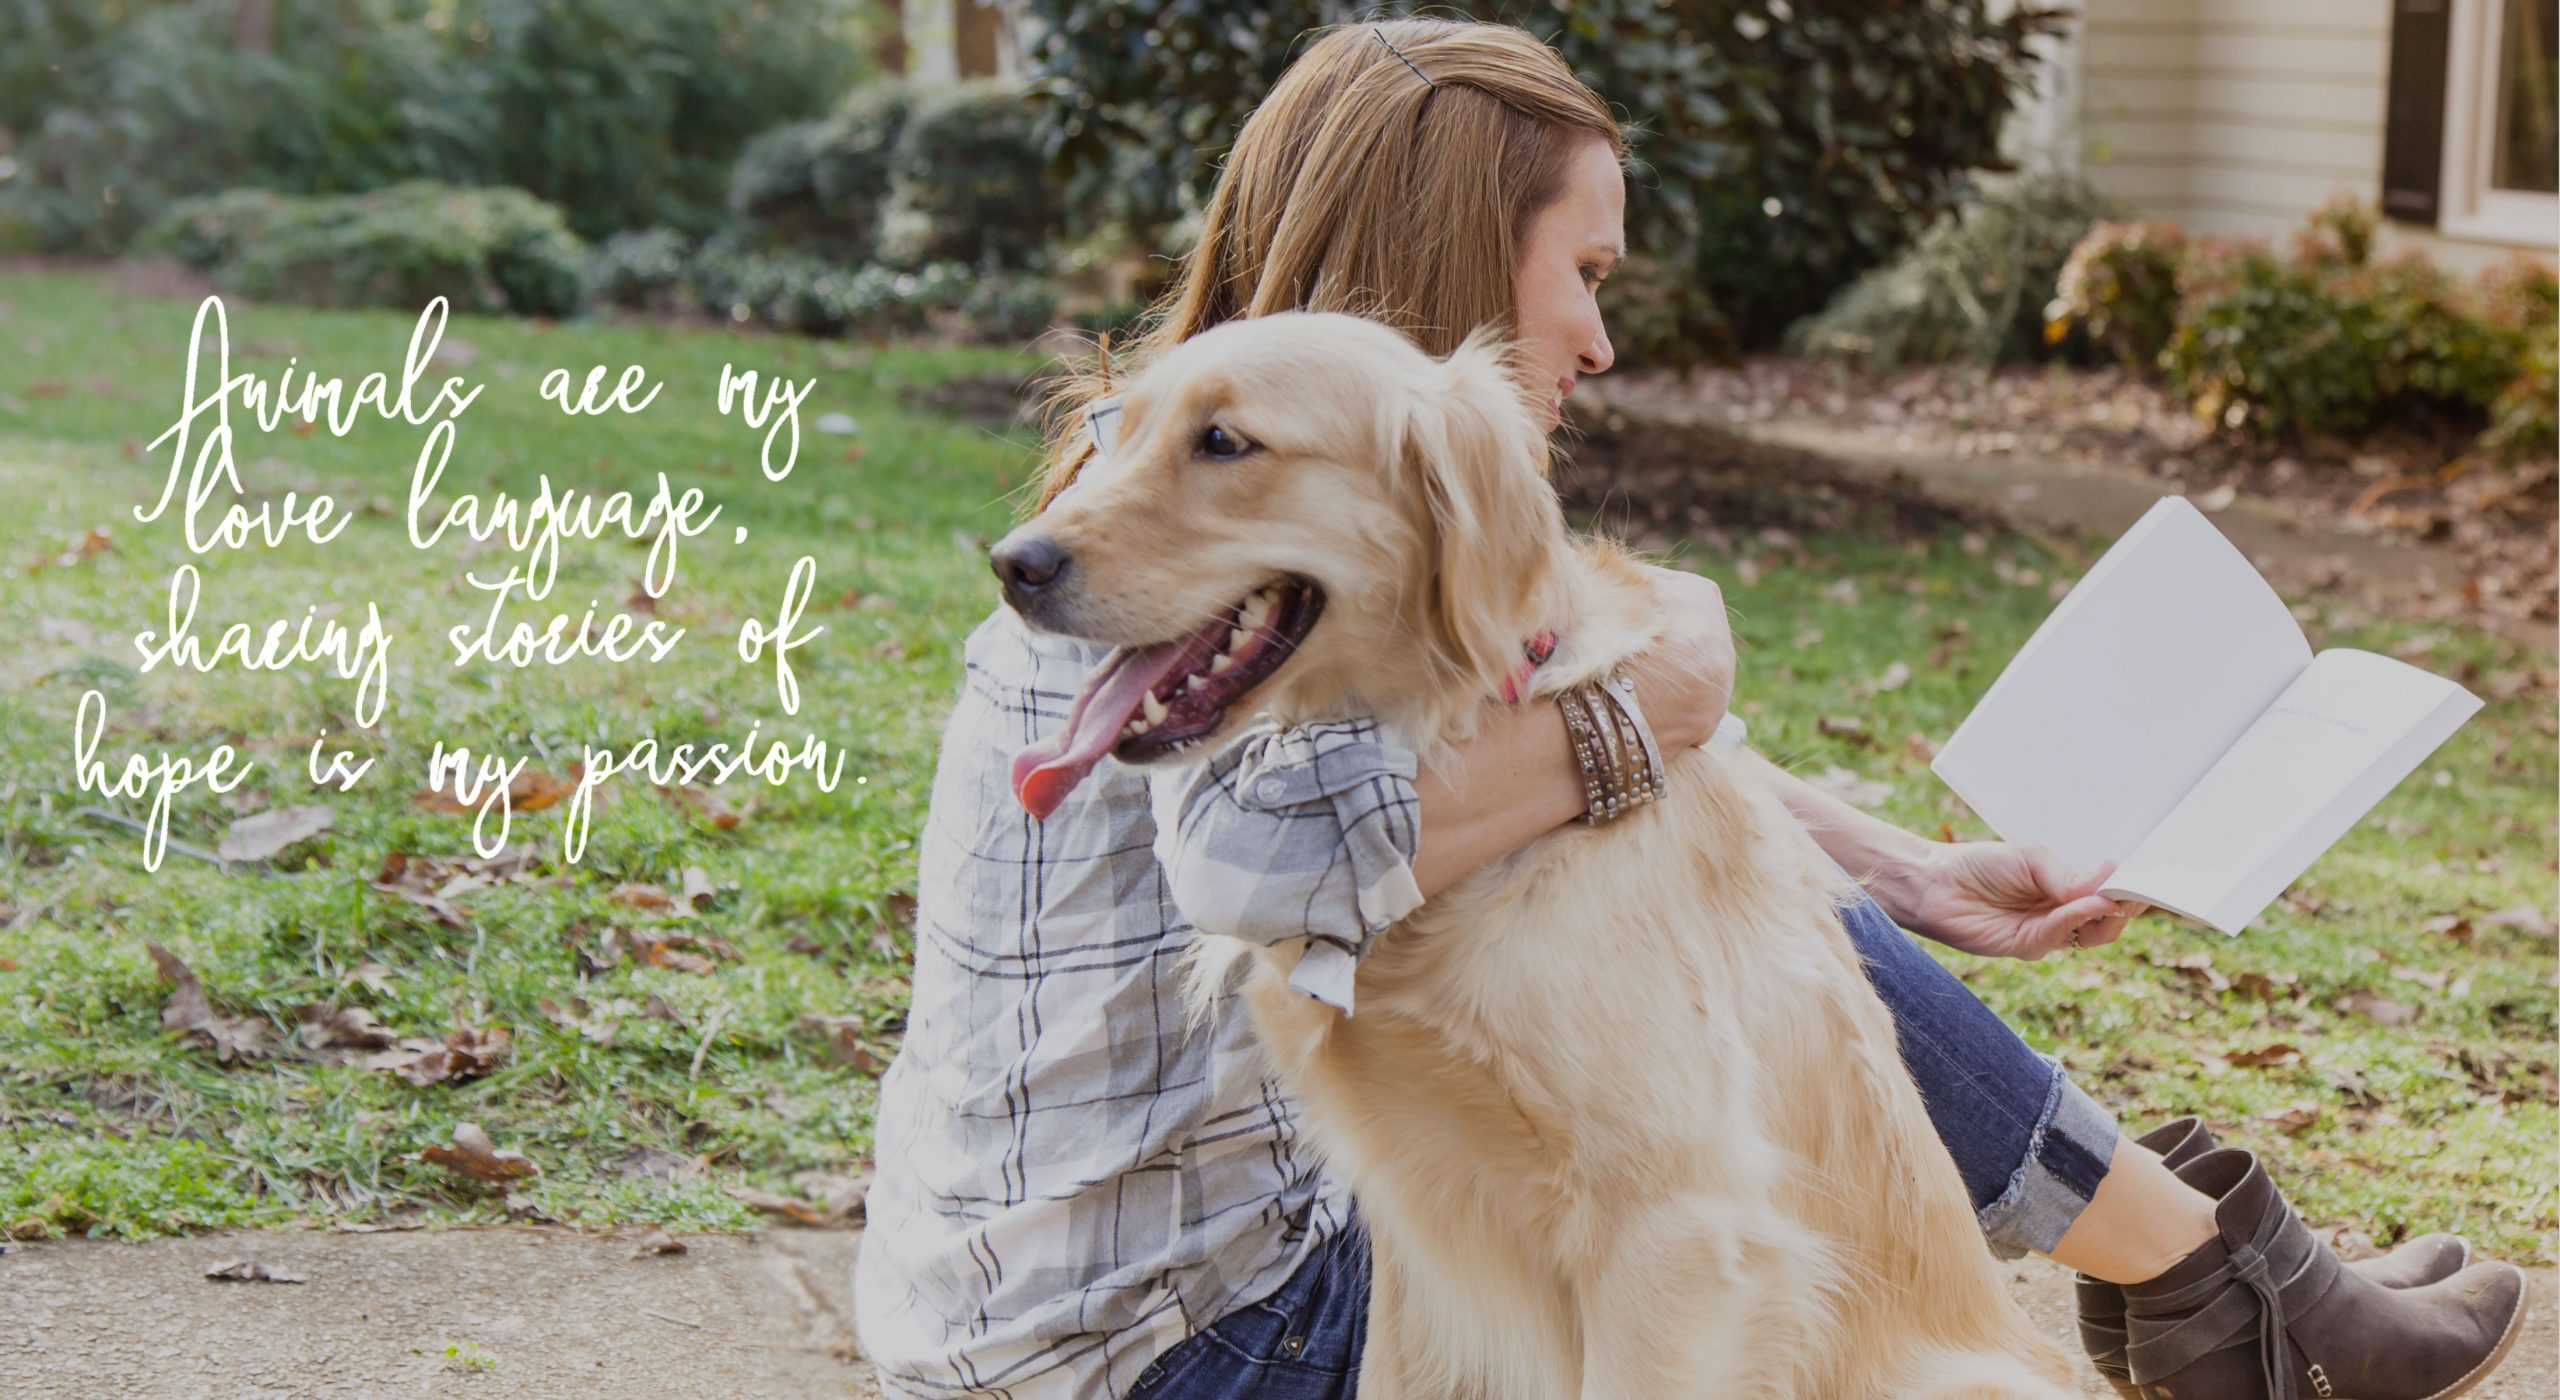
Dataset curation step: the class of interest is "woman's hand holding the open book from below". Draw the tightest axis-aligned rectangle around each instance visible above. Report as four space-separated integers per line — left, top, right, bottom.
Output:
1874 842 2150 962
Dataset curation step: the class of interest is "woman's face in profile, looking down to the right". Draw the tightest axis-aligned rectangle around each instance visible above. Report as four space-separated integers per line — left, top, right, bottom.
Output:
1513 136 1626 427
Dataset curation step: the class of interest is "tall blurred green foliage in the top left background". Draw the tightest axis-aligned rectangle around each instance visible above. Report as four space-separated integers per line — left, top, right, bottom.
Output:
0 0 868 253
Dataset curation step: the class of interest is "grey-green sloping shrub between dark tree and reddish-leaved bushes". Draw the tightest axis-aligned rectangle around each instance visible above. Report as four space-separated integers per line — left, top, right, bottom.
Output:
1789 177 2099 366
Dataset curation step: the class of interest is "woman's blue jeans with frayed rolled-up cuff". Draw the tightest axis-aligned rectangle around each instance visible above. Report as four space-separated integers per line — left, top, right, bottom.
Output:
1129 896 2117 1400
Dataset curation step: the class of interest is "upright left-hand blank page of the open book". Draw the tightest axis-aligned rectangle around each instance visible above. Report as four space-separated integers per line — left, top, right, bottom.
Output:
1930 497 2312 870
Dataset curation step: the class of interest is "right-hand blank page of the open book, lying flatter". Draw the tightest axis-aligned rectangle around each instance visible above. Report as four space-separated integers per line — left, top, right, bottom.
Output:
2107 648 2481 934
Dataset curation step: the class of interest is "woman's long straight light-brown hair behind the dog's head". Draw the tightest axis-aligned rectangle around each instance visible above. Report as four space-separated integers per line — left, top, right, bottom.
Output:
1034 20 1626 509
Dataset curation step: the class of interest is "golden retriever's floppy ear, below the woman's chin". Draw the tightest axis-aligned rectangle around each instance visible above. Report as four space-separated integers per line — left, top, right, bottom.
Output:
1403 330 1564 694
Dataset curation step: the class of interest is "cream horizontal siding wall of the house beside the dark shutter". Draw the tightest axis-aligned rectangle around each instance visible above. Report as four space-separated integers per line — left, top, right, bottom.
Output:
2074 0 2552 269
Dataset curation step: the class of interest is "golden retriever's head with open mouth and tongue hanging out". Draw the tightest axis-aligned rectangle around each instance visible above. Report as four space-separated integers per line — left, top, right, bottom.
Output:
993 312 1564 816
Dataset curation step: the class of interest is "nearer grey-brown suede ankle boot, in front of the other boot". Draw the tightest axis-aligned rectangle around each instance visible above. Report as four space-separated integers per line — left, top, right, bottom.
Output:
2125 1149 2524 1400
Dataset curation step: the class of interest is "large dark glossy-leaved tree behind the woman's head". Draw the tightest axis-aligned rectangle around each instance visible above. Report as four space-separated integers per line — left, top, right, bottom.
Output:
1027 0 2058 358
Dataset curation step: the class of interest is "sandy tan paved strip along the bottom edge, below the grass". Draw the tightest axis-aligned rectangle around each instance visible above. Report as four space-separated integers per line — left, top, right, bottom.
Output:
0 1226 2560 1400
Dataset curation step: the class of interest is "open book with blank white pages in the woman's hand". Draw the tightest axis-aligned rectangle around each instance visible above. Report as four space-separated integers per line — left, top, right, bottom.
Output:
1933 497 2481 934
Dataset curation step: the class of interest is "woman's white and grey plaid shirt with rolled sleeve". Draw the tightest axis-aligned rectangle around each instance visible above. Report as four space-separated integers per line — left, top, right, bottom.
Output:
855 609 1421 1400
